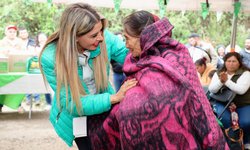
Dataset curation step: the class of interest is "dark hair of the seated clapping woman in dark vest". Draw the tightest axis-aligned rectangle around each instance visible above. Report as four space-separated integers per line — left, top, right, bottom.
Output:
219 52 249 72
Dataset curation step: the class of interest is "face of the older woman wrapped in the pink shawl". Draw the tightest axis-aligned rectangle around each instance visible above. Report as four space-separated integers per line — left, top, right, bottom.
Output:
124 32 141 57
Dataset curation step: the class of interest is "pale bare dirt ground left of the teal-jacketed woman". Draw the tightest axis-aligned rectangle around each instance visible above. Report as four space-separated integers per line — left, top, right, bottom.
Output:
0 104 77 150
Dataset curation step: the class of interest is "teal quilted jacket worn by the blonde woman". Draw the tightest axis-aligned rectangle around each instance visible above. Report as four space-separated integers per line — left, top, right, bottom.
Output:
41 30 128 146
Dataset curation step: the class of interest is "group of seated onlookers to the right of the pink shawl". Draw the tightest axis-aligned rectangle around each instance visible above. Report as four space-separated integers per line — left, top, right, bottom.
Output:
186 33 250 149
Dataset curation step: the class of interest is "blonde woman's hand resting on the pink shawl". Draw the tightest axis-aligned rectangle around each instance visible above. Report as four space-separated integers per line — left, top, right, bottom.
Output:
110 79 138 104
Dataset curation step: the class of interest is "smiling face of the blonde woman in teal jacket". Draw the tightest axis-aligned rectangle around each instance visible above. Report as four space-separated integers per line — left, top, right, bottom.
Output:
77 21 103 50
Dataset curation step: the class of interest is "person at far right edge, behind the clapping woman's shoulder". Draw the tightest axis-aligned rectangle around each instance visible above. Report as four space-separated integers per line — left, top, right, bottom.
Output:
239 36 250 68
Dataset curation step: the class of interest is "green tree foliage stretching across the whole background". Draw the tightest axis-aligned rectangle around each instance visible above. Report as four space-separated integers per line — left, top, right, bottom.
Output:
0 0 250 47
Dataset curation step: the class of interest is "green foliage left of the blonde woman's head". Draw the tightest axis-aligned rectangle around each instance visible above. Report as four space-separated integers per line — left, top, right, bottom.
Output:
0 0 65 38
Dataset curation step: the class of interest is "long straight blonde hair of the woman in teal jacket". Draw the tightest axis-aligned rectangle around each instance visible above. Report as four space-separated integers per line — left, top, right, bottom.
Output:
40 3 108 115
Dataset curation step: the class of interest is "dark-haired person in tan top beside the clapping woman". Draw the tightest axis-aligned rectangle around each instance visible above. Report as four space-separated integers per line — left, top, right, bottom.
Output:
195 57 216 87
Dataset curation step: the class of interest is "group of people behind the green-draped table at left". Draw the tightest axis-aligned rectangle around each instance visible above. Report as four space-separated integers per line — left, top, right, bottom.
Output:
0 25 51 113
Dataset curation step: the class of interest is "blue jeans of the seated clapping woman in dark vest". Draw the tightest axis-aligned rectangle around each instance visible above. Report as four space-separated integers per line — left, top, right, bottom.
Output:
215 102 250 144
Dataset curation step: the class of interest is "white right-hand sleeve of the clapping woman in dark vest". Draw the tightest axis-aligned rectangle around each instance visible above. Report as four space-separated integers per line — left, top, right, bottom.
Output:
225 71 250 95
